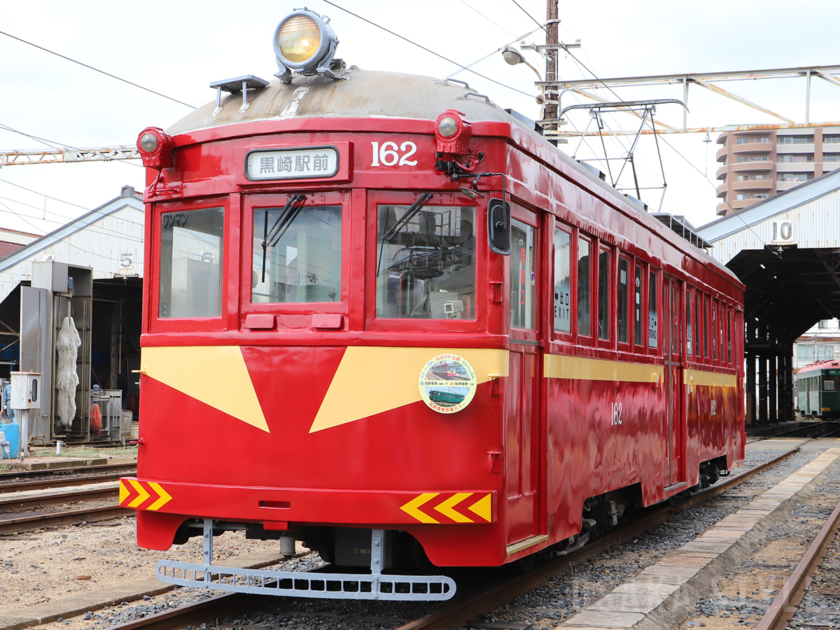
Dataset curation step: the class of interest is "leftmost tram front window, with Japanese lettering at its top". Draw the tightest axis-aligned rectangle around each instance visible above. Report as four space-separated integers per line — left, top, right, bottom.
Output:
158 208 225 319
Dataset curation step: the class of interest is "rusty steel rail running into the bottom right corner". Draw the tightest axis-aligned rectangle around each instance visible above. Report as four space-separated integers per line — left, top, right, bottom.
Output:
756 503 840 630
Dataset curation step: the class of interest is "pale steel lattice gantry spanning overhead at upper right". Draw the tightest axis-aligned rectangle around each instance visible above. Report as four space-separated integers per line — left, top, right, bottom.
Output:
537 65 840 137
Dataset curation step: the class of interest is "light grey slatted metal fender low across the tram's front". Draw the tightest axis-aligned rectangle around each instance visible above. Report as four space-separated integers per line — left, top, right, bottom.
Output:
156 560 457 601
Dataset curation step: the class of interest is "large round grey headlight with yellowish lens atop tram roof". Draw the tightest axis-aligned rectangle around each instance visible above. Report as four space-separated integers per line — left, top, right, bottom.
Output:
274 8 342 83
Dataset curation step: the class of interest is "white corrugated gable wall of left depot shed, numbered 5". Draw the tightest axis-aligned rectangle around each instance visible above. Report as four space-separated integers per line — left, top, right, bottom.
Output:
0 205 145 301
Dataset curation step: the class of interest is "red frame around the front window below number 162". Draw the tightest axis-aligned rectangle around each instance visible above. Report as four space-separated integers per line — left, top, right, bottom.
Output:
366 190 486 332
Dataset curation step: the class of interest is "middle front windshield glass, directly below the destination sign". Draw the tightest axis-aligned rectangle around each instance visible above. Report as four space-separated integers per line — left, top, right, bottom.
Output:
251 206 341 304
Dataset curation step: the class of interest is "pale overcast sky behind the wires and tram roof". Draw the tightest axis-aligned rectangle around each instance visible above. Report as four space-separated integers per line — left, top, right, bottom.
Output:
0 0 840 234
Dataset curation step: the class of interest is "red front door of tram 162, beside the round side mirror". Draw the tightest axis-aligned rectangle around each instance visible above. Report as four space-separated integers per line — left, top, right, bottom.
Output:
505 213 542 545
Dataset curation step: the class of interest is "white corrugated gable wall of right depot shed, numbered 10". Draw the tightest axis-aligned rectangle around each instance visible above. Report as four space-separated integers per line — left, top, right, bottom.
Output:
711 189 840 264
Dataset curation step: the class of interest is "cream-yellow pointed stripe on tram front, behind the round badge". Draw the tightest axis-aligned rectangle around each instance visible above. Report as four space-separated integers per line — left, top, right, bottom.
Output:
309 346 510 433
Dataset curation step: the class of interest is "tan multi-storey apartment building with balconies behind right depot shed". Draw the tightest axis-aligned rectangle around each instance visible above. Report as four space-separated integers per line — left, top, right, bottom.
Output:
717 127 840 216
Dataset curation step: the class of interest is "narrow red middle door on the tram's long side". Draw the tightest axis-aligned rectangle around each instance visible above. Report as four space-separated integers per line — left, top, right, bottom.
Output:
662 276 685 488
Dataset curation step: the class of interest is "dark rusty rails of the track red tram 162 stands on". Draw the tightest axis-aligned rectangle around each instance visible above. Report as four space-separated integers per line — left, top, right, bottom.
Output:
106 446 800 630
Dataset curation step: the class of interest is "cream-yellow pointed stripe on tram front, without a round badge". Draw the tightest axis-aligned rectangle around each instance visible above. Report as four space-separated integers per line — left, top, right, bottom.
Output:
140 346 269 432
